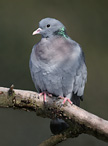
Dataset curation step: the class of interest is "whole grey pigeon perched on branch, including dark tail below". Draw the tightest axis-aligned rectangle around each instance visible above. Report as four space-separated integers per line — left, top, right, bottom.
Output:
29 17 87 134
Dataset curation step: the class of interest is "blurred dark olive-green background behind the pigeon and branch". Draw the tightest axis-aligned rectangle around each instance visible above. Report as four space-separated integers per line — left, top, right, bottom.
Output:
0 0 108 146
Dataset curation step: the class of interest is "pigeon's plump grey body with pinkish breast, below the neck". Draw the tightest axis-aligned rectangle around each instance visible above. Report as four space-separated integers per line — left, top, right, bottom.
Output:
30 37 86 98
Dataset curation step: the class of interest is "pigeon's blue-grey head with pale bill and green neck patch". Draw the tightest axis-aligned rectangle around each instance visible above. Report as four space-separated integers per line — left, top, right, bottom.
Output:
33 18 67 38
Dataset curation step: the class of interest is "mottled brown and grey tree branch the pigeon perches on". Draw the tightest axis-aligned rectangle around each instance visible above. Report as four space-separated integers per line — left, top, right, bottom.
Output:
0 86 108 146
